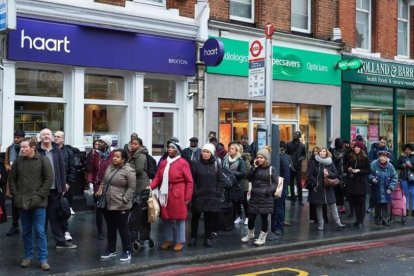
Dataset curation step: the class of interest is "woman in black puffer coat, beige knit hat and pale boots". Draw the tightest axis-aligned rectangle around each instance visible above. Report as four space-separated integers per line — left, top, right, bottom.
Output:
241 147 279 246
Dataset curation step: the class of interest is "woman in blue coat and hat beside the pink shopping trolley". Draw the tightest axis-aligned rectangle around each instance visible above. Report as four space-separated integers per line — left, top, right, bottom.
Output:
368 148 398 226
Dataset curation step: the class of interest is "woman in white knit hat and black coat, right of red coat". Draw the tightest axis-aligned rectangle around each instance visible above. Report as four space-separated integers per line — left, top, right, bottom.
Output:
188 143 224 247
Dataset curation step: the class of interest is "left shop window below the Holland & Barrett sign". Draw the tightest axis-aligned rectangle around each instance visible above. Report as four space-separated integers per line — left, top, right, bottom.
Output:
351 85 393 150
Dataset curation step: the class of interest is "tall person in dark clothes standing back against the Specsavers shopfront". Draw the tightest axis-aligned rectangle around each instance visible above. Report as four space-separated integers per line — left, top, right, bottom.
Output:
286 131 306 206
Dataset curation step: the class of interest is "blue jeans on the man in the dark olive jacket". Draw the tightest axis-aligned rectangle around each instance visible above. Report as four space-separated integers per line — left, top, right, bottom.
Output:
20 208 47 262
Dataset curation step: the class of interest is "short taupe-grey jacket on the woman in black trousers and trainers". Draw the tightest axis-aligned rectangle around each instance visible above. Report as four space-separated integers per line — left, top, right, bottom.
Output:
101 163 136 210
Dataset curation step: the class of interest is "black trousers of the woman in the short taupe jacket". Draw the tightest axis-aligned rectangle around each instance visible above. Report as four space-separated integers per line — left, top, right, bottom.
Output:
103 209 131 252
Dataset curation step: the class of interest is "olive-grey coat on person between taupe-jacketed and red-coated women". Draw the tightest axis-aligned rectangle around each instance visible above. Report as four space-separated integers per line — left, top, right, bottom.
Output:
128 146 150 194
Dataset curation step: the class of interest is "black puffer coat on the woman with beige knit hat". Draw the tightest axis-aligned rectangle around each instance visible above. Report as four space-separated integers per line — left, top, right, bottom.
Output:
246 166 278 214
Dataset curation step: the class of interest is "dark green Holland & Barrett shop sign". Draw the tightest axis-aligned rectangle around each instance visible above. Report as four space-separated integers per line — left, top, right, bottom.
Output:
342 56 414 89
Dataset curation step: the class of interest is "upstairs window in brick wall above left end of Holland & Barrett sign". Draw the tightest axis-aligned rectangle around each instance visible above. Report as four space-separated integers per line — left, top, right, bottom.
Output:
355 0 371 51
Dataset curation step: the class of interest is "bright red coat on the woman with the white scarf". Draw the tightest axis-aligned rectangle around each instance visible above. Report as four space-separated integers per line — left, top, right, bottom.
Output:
151 158 194 220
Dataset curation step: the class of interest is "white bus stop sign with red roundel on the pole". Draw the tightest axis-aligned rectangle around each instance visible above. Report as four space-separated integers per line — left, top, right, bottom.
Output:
248 39 265 97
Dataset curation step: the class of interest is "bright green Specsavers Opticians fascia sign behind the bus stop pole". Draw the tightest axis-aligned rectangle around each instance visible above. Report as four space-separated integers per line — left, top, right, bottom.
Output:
207 38 341 86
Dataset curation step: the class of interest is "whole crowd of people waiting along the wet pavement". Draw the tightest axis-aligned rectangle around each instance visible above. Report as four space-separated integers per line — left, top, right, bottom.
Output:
2 129 414 270
